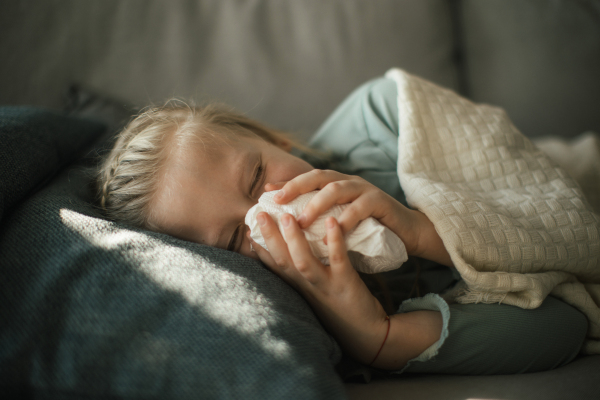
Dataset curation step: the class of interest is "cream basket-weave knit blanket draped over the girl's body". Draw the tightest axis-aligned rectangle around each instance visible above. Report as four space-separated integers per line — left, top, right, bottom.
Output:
386 69 600 354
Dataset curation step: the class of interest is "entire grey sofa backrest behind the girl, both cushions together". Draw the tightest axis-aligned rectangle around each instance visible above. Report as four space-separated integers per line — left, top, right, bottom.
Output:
0 0 600 139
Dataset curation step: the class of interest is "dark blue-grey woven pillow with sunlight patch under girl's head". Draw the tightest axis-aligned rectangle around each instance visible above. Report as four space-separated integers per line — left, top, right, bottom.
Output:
0 104 346 399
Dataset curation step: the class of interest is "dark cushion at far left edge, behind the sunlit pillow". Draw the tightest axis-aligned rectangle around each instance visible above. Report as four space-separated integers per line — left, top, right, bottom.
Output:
0 106 105 220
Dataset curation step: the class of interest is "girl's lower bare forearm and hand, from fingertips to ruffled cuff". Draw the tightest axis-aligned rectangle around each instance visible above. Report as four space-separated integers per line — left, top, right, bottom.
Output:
247 213 442 370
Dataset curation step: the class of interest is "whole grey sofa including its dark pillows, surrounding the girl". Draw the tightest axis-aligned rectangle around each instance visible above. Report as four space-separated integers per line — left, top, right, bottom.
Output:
0 0 600 399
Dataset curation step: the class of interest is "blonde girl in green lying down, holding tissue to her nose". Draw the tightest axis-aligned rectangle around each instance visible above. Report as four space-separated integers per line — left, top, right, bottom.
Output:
98 78 587 374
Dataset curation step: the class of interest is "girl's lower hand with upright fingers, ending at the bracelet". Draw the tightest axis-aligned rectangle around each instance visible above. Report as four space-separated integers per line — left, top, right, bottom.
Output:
248 212 387 364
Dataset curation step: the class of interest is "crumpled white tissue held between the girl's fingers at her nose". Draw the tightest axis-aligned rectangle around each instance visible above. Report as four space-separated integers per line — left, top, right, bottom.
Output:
246 190 408 274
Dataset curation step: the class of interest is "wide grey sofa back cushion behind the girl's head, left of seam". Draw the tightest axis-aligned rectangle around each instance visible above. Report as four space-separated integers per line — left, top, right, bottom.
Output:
0 0 457 142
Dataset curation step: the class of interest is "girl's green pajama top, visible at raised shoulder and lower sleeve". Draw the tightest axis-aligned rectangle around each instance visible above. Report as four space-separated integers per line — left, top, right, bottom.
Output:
303 78 587 374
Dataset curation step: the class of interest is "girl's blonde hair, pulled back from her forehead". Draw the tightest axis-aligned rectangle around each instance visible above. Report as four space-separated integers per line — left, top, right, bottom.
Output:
96 101 305 230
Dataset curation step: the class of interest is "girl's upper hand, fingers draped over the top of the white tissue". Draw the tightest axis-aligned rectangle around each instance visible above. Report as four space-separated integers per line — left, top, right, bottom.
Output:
265 169 453 266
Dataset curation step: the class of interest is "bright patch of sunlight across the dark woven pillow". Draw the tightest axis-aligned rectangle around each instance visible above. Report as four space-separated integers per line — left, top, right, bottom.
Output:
60 209 291 359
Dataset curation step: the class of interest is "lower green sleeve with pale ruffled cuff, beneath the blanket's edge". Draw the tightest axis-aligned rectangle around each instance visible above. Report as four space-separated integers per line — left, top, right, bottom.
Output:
396 294 588 375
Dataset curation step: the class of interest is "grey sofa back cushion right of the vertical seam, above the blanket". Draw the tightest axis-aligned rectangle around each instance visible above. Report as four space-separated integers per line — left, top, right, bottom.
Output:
457 0 600 137
